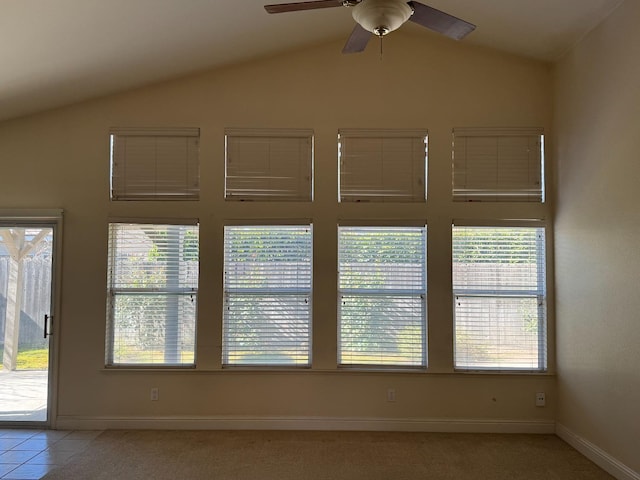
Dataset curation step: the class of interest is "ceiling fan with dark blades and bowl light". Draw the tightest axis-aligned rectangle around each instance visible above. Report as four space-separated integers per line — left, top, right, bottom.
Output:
264 0 476 53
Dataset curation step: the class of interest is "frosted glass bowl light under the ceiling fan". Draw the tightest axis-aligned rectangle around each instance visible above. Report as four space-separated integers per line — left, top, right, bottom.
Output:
352 0 413 37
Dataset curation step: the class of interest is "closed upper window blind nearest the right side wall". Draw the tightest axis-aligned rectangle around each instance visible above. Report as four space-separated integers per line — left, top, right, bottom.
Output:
453 128 544 202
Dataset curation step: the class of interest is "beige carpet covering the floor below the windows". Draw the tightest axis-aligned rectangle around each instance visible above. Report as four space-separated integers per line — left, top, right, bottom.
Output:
44 430 613 480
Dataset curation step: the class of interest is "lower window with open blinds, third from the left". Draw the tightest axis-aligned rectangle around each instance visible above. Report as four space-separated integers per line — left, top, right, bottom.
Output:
338 226 427 367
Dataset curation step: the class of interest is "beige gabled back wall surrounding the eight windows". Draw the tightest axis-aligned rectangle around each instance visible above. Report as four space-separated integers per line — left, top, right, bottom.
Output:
0 31 557 430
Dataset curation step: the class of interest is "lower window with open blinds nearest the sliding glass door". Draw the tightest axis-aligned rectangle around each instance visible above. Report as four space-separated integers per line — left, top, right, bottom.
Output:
107 223 199 366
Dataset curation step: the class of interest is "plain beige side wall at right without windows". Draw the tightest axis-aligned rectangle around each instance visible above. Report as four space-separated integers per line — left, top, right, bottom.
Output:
555 1 640 472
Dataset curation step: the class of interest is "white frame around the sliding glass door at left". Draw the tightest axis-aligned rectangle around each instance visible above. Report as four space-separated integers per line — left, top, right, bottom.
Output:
0 209 63 429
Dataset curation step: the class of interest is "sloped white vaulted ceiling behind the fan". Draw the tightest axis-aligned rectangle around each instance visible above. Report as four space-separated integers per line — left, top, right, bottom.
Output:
0 0 623 121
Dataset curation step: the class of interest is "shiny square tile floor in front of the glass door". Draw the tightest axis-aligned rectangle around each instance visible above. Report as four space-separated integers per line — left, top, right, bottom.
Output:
0 429 101 480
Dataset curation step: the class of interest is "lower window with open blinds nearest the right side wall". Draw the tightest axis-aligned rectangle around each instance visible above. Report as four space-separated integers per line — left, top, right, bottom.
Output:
453 226 547 371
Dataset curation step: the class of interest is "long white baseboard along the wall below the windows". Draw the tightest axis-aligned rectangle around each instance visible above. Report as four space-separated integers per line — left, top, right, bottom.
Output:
55 415 555 434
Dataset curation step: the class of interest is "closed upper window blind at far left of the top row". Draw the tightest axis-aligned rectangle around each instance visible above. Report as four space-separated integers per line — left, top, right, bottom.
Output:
111 128 200 200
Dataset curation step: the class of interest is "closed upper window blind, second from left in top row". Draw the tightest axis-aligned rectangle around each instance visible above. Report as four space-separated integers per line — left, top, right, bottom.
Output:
225 129 313 201
